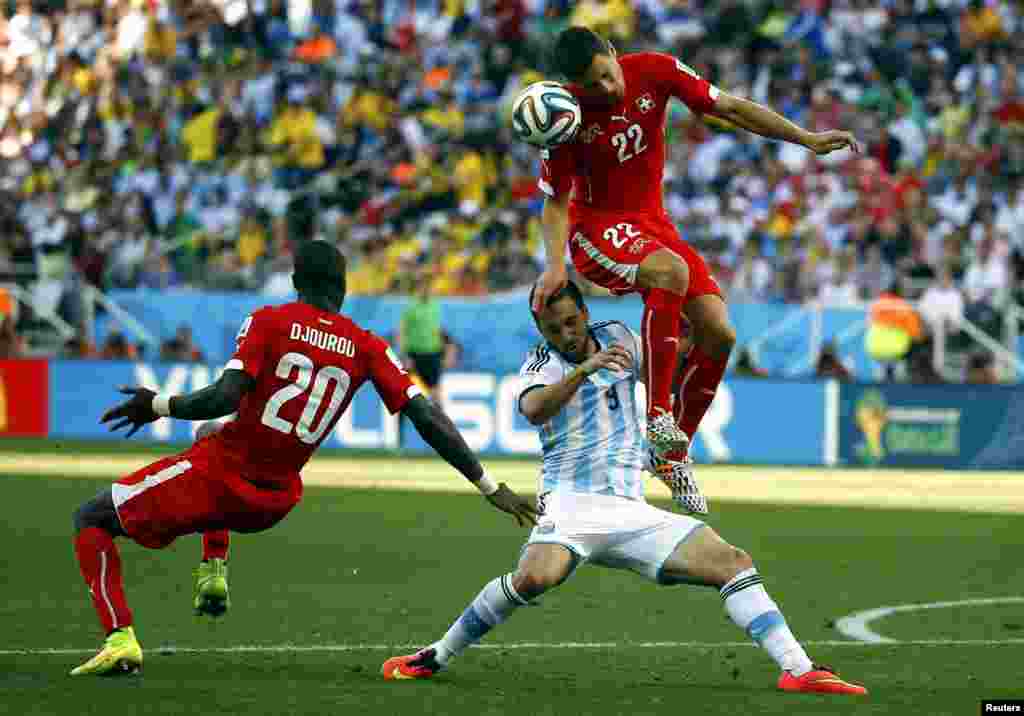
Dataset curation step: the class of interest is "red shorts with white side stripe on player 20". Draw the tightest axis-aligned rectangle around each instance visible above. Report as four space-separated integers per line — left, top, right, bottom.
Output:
112 440 302 549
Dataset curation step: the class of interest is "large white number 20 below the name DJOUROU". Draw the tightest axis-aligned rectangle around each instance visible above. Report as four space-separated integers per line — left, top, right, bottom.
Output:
260 352 352 445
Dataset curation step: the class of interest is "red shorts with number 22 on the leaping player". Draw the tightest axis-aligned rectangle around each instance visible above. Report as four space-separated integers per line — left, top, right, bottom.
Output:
569 212 722 303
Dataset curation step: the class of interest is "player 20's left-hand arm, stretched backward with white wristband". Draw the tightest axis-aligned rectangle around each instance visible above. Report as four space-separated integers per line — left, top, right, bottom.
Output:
99 369 256 437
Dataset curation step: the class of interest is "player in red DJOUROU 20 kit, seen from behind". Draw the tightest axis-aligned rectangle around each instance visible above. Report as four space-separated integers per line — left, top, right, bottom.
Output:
72 242 536 675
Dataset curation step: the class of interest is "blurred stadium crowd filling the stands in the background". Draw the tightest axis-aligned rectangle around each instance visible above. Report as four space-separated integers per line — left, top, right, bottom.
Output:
0 0 1024 364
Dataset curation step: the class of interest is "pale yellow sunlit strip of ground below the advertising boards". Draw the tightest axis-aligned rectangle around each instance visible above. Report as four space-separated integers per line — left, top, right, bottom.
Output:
6 453 1024 514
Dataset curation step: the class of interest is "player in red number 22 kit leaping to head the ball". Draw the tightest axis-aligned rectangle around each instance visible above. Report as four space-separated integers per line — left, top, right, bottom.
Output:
532 28 859 512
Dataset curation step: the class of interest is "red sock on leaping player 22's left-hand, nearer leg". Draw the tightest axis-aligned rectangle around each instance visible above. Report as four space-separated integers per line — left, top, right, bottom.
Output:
641 289 683 417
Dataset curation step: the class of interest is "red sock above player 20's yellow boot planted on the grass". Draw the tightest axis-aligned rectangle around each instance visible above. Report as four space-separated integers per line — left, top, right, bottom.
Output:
75 528 132 634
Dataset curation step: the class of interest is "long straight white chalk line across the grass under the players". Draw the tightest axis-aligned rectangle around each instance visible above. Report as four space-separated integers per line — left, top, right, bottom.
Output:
0 639 1024 657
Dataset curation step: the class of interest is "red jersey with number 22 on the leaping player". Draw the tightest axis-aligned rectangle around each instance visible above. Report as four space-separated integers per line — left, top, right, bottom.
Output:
538 52 719 221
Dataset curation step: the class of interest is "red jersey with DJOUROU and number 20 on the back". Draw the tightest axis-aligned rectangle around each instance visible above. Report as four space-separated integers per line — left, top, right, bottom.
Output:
212 301 420 483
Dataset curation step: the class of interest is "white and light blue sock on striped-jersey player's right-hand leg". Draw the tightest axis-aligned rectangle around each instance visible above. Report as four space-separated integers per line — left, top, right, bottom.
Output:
719 567 813 676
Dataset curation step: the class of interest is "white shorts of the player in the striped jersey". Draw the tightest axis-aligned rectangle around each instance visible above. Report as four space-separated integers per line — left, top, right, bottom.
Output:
523 492 703 584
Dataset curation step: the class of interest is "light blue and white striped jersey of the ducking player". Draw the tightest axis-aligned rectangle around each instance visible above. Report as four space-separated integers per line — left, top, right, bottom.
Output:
519 321 646 500
